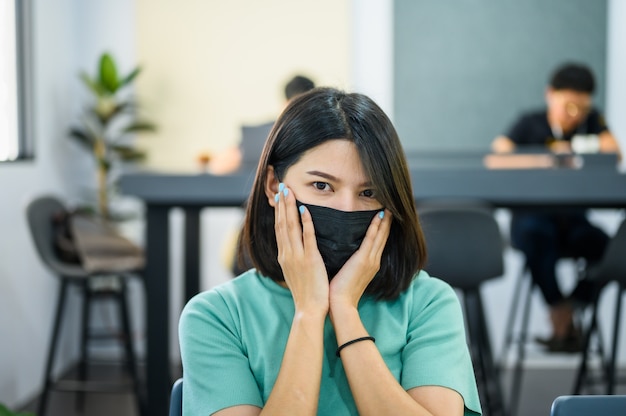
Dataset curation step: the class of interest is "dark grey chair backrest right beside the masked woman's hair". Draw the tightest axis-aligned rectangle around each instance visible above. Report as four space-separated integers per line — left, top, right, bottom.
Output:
417 201 504 290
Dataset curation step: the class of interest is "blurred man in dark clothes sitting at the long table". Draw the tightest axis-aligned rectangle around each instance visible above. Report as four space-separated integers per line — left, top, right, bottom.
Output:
492 64 619 352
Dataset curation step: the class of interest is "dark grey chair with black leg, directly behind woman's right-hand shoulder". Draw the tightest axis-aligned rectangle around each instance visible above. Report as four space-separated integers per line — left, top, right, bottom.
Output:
417 201 505 415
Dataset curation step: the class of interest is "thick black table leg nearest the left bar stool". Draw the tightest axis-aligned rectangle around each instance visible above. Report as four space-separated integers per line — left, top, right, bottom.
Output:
145 205 172 416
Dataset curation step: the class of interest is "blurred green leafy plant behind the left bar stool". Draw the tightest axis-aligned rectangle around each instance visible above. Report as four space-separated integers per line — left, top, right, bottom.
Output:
70 52 155 219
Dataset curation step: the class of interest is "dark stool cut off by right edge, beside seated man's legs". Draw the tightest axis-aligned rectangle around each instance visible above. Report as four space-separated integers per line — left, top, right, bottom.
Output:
573 219 626 394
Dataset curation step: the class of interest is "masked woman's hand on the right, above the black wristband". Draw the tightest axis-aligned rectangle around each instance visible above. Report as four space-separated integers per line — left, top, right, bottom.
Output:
329 210 392 312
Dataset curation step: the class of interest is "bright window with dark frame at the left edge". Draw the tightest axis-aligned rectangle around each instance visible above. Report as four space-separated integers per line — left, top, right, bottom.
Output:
0 0 33 162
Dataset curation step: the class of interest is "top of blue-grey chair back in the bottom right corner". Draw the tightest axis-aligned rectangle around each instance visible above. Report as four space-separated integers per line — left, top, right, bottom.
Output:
550 395 626 416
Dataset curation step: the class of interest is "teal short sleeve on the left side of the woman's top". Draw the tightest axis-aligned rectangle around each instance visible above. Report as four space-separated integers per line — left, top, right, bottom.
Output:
178 290 263 416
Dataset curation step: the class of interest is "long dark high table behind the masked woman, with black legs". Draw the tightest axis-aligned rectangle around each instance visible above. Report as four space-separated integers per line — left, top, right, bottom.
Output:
120 162 626 416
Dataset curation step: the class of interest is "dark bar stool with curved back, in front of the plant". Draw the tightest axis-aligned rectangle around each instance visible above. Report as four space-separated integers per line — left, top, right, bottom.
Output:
26 196 143 416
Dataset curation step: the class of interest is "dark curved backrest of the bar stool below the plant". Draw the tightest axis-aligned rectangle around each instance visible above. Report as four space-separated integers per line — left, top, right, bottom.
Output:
26 196 67 272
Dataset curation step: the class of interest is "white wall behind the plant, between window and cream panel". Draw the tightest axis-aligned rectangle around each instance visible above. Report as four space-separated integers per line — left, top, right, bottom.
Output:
0 0 134 407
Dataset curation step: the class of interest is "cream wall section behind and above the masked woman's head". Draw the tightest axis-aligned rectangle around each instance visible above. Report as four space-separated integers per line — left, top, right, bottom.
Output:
136 0 351 171
